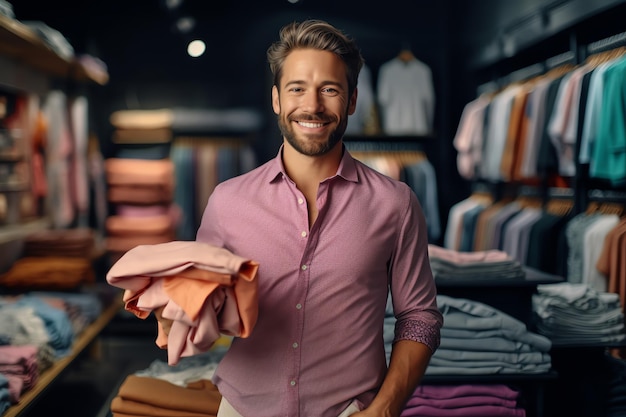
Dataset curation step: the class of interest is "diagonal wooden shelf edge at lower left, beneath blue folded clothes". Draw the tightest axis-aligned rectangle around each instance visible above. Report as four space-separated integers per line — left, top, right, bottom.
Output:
2 299 123 417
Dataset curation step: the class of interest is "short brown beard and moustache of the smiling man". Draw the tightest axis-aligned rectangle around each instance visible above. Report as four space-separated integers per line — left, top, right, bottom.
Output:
278 110 348 156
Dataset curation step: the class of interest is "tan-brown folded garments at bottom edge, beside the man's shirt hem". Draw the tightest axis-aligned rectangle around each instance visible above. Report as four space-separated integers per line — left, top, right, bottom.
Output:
111 374 222 416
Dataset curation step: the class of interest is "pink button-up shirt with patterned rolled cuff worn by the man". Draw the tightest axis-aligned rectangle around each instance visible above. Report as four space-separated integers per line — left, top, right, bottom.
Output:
197 145 442 417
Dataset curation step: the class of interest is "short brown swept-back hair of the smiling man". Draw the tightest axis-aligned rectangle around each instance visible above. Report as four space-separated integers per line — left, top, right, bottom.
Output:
267 20 363 95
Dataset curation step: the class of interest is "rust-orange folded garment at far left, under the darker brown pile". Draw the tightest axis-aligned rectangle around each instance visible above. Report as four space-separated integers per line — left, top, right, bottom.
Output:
0 256 95 289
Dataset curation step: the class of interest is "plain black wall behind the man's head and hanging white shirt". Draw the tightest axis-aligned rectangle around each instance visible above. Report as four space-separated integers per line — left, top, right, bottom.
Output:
14 0 448 159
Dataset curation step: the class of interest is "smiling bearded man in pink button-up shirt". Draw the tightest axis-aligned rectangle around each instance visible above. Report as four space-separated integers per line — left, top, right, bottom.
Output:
161 20 442 417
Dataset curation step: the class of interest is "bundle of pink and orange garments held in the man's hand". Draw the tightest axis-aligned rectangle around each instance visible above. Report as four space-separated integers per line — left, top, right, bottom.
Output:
106 241 259 365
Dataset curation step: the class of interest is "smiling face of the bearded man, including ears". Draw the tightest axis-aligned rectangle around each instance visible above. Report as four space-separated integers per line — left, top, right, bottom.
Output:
272 49 356 156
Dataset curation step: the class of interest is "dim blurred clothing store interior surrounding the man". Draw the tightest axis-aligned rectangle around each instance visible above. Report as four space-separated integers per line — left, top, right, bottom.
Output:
0 0 626 417
